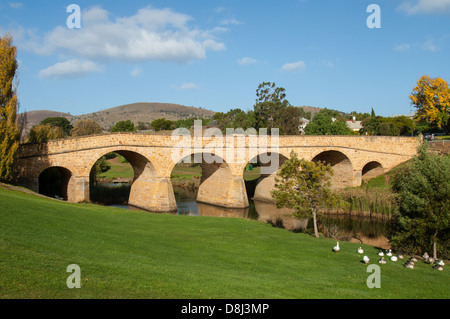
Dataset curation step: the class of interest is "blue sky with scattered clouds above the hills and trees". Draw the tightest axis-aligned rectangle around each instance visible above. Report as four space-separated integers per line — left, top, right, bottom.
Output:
0 0 450 116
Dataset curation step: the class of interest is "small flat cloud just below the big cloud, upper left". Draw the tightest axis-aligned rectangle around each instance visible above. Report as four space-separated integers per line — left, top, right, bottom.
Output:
39 59 101 79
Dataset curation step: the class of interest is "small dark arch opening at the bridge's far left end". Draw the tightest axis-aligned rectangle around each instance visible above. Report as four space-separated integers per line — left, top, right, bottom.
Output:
38 166 73 201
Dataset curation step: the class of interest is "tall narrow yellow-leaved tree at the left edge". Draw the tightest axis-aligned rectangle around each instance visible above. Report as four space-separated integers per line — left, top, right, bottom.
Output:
0 35 20 182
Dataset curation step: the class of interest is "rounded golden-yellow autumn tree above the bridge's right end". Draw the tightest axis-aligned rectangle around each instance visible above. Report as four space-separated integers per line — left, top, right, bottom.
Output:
409 75 450 133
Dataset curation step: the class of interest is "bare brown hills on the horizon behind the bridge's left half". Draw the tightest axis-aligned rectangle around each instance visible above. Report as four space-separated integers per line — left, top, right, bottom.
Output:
25 103 216 131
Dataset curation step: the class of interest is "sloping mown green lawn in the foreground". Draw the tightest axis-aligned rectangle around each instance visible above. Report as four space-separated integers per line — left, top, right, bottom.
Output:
0 186 450 299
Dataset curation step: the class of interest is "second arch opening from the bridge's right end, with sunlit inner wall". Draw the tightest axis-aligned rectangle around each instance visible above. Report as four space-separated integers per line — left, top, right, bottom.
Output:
312 150 355 189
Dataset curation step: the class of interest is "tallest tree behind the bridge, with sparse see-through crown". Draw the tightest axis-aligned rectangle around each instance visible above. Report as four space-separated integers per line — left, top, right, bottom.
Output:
253 82 290 134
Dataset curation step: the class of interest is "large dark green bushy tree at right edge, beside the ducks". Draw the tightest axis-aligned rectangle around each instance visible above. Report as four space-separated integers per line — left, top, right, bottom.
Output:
390 143 450 259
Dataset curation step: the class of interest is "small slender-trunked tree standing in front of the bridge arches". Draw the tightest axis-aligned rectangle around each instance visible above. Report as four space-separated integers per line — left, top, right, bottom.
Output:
271 151 339 237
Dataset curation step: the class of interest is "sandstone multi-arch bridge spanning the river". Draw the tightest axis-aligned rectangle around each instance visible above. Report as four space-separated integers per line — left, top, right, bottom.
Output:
16 133 421 211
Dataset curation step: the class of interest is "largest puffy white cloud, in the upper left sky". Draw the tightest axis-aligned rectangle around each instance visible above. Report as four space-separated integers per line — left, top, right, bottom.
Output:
16 7 225 63
